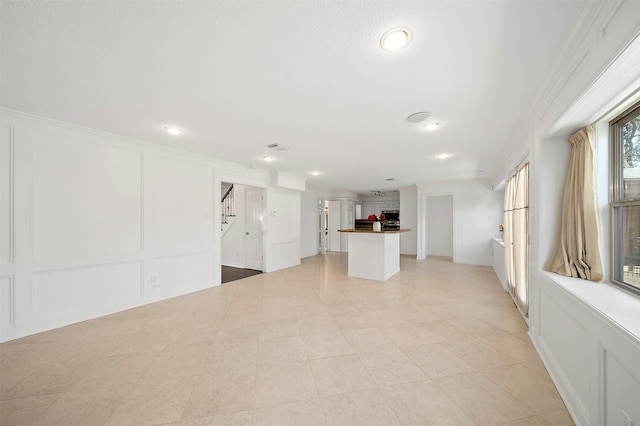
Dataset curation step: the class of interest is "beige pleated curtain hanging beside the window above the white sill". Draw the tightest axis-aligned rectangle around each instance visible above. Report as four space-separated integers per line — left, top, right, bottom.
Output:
551 126 604 281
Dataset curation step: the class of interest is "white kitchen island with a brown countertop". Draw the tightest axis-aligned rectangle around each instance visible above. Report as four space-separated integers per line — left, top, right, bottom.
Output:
339 229 409 281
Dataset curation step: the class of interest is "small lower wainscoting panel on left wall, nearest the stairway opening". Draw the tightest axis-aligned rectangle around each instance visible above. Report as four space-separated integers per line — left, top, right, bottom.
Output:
151 251 213 299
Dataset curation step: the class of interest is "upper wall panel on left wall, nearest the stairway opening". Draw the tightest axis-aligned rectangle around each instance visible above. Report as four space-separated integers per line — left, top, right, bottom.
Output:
151 156 215 249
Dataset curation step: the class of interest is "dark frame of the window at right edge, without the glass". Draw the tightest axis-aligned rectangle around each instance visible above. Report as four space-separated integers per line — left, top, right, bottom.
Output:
609 102 640 294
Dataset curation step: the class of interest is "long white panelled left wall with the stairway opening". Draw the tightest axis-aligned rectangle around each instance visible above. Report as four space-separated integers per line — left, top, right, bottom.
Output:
0 109 300 341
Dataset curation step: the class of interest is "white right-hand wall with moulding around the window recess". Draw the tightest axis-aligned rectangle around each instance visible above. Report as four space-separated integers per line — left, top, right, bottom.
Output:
493 1 640 425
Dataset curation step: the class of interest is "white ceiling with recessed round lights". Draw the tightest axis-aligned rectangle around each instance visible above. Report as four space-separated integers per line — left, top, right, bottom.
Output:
0 0 586 192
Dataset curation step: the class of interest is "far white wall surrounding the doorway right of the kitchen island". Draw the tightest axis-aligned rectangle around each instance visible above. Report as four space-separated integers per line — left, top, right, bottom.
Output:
418 180 503 265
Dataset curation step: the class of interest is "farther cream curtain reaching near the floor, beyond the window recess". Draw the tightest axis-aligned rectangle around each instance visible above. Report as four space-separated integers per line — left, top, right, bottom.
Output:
503 163 529 316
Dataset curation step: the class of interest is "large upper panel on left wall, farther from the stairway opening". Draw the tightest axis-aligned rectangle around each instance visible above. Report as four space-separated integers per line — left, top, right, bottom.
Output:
32 132 142 262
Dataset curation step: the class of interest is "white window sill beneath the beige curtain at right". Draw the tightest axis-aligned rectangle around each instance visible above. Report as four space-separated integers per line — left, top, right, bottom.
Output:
541 271 640 340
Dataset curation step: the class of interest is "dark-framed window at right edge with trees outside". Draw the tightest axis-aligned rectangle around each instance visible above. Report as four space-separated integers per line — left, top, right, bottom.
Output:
610 104 640 293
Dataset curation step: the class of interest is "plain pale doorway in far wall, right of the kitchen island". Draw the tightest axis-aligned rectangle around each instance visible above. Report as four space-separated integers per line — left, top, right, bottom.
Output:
427 195 453 256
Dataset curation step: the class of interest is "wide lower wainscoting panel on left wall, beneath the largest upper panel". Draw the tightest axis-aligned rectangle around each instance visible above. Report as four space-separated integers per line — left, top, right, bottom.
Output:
31 261 142 328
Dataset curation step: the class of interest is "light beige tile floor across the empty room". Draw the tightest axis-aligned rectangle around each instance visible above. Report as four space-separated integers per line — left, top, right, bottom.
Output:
0 253 573 426
